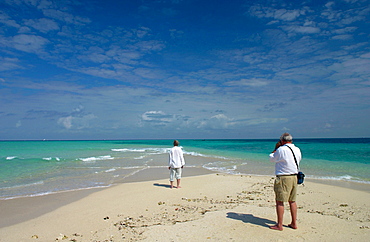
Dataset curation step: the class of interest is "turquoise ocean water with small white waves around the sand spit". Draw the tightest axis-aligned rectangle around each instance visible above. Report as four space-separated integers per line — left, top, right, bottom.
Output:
0 138 370 200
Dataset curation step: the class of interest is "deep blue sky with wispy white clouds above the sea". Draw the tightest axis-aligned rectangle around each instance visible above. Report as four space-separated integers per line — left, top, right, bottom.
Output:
0 0 370 139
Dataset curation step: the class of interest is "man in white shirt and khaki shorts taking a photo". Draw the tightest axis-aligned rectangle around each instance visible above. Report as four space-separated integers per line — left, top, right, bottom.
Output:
270 133 302 230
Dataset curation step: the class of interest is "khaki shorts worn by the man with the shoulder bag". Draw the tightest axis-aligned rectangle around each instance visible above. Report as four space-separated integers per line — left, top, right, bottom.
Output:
274 175 298 202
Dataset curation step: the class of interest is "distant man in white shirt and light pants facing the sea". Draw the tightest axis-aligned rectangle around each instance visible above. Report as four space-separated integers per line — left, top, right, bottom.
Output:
168 140 185 188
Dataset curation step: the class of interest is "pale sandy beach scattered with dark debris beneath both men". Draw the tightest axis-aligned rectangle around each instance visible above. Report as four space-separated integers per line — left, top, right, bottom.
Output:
0 168 370 241
